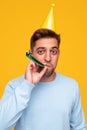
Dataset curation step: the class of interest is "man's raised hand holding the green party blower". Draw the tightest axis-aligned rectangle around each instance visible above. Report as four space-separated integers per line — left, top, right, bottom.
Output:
25 61 47 84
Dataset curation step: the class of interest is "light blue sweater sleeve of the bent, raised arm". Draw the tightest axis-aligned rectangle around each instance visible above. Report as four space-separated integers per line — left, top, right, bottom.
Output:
0 79 34 130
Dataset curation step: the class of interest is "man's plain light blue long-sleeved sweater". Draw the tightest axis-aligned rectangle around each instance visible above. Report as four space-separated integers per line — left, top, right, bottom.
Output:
0 73 85 130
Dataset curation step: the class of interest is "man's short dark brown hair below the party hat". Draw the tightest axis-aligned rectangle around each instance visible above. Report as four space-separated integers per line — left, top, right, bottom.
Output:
30 28 60 49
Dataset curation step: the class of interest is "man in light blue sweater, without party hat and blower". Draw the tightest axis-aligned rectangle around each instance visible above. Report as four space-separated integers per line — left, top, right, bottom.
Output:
0 29 85 130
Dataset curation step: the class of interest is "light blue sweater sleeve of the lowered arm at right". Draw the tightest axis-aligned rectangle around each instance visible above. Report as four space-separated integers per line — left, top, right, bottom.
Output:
70 84 86 130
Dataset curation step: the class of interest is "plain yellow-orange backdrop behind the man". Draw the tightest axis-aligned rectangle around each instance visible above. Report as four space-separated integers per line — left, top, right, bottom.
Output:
0 0 87 121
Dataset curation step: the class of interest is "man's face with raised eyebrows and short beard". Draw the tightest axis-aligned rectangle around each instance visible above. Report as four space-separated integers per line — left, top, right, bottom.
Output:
32 38 59 76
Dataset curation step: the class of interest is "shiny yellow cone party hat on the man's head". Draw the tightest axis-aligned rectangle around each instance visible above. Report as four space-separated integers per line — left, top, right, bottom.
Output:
41 3 55 31
